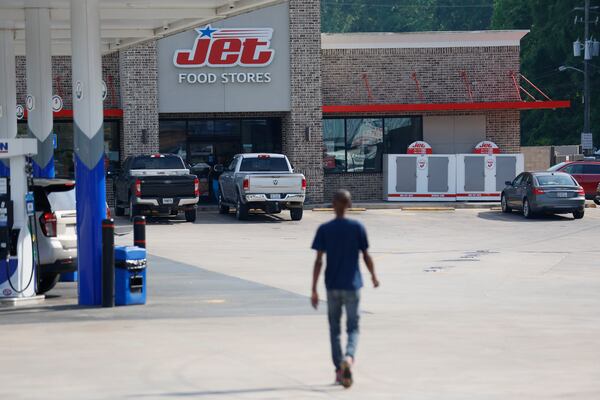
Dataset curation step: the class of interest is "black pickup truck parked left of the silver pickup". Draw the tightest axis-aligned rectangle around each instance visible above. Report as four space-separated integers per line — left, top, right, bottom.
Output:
114 154 200 222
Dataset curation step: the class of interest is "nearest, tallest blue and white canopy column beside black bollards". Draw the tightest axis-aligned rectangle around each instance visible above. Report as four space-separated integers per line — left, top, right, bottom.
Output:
71 0 106 305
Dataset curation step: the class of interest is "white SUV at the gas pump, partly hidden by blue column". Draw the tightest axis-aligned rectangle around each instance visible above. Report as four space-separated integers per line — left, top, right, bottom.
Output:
32 179 77 293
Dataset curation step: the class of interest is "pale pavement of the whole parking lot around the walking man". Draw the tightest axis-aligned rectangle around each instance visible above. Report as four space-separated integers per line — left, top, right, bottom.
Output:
0 209 600 400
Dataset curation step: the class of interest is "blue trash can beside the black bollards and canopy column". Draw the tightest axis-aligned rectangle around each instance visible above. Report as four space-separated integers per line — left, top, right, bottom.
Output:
115 246 146 306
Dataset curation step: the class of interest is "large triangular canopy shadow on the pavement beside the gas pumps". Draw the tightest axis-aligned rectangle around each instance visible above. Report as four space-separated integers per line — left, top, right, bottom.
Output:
0 255 324 325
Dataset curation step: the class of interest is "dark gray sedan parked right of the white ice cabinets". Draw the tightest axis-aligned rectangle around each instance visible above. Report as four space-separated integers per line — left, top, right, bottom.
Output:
501 172 585 219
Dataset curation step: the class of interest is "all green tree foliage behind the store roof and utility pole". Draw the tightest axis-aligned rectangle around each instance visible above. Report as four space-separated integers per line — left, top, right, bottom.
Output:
321 0 600 145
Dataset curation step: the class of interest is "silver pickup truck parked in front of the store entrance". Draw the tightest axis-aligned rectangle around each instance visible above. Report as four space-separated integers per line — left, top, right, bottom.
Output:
215 154 306 221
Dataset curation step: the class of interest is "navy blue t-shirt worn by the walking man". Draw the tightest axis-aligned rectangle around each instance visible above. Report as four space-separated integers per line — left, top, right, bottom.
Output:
312 218 369 290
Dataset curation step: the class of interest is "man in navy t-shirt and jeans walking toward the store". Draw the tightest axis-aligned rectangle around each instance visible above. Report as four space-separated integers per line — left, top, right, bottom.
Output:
311 190 379 388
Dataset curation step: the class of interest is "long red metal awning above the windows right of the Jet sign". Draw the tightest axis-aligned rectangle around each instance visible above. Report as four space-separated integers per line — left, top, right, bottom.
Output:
323 100 571 114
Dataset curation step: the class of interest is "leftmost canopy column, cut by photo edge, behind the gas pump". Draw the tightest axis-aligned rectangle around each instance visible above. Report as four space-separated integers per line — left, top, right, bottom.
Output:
0 29 17 177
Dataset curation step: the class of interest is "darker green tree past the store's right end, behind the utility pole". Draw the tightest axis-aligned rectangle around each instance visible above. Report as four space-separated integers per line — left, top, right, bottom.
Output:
491 0 600 145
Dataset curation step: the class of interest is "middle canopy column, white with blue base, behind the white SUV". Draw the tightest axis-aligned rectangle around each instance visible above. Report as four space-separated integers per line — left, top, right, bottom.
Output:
25 8 54 178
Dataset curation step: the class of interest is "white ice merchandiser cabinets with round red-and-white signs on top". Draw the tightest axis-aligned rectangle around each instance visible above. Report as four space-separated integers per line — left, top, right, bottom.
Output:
383 141 524 201
